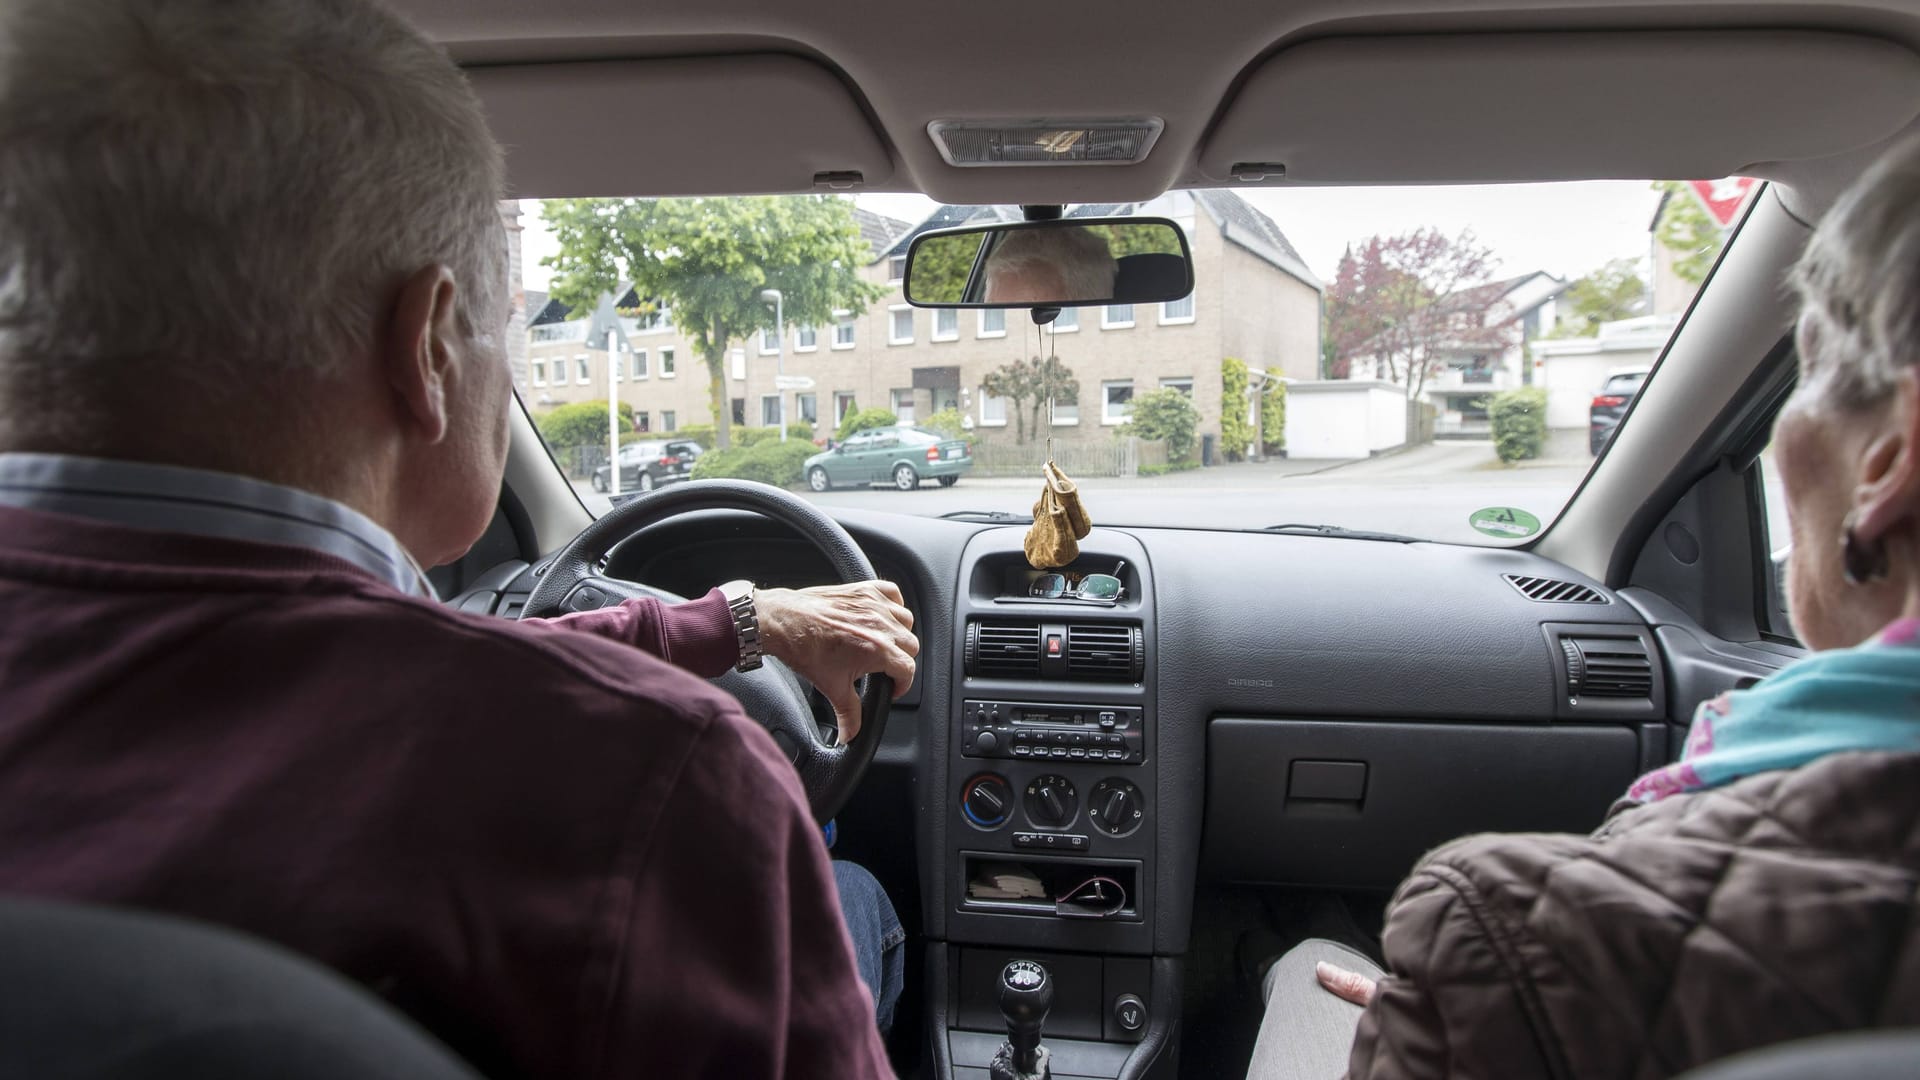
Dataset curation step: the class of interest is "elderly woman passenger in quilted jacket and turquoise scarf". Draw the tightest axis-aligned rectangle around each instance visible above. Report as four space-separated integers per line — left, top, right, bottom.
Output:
1252 140 1920 1078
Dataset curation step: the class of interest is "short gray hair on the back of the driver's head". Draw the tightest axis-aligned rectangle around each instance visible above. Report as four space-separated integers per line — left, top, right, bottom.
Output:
0 0 507 400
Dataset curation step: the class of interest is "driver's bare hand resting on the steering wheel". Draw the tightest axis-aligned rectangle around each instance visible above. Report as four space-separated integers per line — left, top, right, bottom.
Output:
753 580 920 746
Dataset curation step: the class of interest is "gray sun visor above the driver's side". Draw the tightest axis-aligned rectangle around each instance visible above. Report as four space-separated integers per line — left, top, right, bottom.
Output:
467 54 893 198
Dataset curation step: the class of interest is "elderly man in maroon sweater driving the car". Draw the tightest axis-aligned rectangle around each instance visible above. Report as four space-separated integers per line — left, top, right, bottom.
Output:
0 0 916 1078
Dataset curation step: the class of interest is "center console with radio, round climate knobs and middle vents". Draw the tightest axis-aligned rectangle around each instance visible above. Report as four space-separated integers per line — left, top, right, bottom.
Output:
929 528 1190 1080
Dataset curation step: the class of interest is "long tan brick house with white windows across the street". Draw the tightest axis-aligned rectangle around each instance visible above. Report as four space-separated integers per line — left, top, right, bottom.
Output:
522 190 1321 449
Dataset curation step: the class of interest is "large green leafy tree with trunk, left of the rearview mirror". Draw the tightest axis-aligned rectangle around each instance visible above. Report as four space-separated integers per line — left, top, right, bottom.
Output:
540 196 887 448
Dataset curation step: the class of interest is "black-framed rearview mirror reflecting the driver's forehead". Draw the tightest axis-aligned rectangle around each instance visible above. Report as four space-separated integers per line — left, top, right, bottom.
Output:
902 217 1194 307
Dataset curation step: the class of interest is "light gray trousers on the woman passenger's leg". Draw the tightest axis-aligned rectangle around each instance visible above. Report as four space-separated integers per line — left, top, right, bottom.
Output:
1246 938 1382 1080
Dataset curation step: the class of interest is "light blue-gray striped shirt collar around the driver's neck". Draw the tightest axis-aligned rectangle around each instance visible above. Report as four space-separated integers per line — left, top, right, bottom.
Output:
0 454 434 598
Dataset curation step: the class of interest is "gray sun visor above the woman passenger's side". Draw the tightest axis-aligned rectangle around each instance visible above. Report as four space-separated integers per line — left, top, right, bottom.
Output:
1198 31 1920 184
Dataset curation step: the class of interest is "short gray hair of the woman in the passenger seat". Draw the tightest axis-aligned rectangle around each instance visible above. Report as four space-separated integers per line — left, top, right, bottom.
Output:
1788 138 1920 405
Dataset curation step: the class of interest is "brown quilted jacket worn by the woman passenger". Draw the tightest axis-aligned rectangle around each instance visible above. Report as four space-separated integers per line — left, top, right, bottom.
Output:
1350 753 1920 1080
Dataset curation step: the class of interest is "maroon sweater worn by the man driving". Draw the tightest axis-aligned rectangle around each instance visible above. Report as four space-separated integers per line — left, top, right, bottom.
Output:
0 509 891 1078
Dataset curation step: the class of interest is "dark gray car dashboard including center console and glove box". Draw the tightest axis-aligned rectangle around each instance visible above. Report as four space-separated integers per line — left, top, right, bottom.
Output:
463 511 1720 1078
